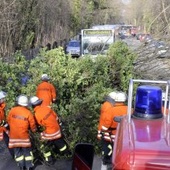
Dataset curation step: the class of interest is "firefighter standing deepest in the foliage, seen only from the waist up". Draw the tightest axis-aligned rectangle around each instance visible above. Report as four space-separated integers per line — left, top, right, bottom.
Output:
36 74 57 106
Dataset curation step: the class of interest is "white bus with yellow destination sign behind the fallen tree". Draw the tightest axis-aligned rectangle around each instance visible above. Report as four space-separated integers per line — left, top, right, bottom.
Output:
80 29 115 56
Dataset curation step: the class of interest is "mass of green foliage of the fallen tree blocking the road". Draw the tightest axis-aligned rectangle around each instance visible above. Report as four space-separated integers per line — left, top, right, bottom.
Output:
0 42 135 155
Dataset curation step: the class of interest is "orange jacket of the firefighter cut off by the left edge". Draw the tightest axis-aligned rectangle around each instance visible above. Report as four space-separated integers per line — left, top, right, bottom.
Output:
0 103 7 141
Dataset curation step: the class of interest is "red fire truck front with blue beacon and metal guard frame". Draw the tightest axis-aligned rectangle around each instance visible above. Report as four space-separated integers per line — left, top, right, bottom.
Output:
112 80 170 170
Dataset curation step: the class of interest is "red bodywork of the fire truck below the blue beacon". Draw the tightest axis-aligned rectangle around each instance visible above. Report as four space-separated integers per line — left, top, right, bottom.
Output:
112 117 170 170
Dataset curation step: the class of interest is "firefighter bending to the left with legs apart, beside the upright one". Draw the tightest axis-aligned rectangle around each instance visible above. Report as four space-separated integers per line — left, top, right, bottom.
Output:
30 96 68 165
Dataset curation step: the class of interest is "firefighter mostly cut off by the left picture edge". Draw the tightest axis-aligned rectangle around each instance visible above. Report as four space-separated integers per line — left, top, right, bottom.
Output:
0 91 8 141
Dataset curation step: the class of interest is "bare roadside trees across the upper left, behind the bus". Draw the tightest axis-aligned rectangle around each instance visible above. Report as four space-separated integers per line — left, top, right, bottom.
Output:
0 0 121 56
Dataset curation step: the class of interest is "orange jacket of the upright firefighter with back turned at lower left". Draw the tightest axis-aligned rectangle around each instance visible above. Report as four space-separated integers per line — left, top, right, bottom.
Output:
7 106 36 148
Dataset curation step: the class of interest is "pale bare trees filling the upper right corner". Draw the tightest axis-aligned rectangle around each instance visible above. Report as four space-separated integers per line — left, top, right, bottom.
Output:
126 0 170 37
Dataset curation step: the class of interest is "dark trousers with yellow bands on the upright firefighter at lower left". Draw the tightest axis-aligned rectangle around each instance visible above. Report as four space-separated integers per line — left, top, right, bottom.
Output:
14 147 34 168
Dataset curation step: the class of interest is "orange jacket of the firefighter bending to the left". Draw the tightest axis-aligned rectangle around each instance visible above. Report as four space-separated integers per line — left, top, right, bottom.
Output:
34 106 61 140
